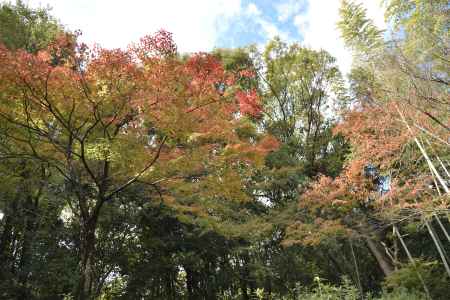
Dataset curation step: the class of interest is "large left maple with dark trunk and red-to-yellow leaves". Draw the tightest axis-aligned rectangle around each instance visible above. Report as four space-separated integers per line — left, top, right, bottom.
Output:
0 31 277 299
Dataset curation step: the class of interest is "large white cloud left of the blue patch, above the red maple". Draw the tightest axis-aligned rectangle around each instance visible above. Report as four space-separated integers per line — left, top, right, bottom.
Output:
24 0 241 52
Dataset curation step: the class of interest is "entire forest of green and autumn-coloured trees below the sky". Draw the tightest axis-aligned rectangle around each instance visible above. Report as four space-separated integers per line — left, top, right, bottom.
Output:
0 0 450 300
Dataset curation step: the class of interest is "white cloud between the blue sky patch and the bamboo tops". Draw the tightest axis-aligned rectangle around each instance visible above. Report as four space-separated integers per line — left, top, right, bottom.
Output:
294 0 386 74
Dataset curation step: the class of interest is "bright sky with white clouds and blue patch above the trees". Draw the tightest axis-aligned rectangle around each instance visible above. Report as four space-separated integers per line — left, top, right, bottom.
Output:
15 0 385 73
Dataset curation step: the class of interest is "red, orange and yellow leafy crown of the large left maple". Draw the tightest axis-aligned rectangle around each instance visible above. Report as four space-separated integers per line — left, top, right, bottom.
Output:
0 31 276 204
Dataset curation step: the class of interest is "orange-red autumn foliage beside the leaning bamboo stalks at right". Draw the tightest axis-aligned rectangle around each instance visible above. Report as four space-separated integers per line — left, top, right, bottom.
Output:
285 102 448 244
